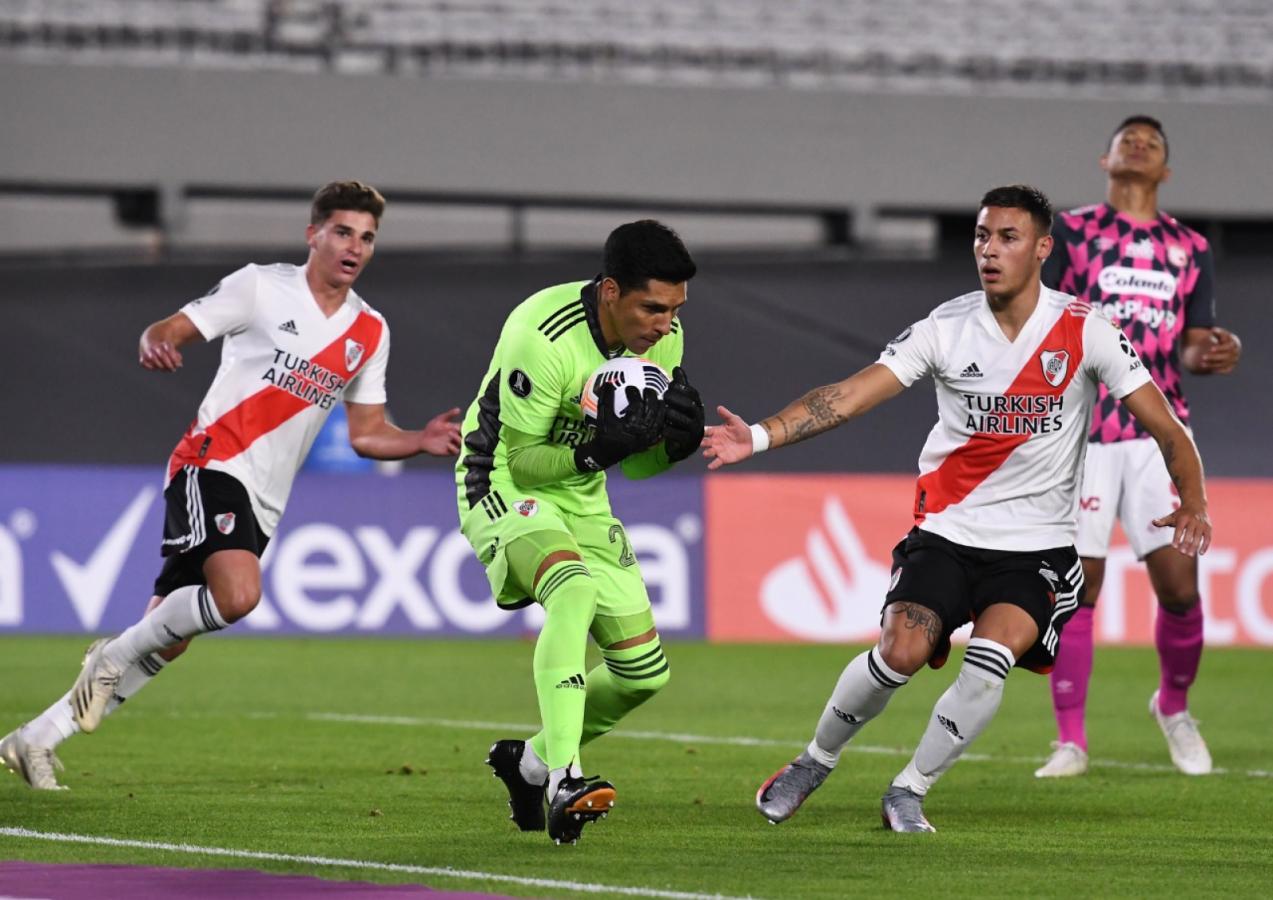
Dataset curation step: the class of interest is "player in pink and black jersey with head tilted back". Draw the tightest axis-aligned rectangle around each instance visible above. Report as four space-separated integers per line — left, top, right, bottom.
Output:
1035 116 1241 778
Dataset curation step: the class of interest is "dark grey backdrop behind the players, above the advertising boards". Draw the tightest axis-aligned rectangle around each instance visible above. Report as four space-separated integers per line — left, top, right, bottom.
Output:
0 249 1273 477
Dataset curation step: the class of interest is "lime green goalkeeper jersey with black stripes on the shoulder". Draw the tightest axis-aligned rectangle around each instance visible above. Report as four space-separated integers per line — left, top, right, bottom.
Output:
456 281 684 519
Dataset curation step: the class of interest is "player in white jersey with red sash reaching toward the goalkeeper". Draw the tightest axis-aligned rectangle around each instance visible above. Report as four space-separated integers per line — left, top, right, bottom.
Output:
704 185 1211 831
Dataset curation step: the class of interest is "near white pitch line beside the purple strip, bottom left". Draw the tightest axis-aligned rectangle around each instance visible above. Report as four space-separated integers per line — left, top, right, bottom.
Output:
0 827 743 900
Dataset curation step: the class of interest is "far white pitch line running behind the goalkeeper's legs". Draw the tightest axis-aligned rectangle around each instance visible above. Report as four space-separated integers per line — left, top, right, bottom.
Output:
304 713 1273 778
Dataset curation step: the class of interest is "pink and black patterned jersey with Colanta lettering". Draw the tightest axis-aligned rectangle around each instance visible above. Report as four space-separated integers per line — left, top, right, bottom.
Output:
1043 204 1216 443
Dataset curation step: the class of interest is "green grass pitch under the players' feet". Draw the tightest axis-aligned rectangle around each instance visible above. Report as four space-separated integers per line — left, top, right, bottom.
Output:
0 636 1273 897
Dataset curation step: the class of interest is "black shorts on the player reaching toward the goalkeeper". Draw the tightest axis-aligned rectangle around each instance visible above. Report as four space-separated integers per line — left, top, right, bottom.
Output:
885 528 1083 672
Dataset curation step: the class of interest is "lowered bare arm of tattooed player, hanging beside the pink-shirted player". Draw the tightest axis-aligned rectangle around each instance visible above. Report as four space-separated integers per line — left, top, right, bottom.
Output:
1123 382 1211 556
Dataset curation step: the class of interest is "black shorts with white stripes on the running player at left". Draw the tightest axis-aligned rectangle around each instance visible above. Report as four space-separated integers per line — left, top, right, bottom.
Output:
155 466 270 597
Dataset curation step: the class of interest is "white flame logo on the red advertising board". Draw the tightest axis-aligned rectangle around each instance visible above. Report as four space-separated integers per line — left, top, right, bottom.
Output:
760 496 889 642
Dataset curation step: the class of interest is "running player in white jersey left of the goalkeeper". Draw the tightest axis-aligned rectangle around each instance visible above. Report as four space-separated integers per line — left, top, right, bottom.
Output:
0 181 460 791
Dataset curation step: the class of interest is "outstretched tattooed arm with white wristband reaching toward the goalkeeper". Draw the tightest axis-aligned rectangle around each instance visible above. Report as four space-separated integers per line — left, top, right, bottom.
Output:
703 363 905 468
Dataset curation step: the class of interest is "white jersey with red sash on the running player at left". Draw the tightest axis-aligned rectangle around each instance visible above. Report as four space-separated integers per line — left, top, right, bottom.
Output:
167 264 390 535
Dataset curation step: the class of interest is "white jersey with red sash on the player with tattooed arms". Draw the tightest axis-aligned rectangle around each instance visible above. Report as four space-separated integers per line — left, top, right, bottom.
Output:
878 286 1151 551
